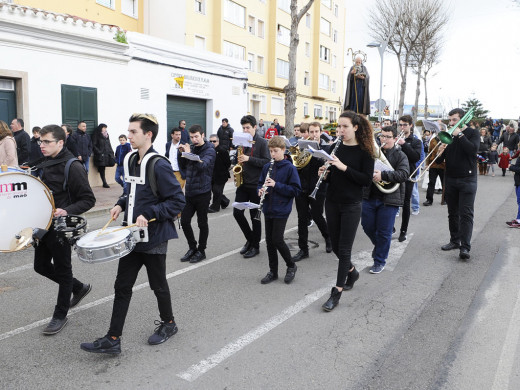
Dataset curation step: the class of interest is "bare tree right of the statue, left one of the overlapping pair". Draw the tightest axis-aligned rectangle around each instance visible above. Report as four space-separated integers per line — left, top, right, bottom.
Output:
370 0 446 115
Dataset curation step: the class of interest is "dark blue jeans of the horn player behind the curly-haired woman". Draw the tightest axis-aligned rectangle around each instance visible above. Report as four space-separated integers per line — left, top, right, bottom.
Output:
361 199 399 265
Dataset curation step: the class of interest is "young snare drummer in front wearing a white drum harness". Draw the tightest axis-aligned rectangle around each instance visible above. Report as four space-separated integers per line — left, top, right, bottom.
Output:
81 114 185 354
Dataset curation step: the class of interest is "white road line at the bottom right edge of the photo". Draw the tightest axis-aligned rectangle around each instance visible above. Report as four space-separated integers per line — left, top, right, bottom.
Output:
492 248 520 390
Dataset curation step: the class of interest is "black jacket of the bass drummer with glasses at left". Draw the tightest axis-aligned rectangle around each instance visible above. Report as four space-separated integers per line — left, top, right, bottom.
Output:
42 148 96 215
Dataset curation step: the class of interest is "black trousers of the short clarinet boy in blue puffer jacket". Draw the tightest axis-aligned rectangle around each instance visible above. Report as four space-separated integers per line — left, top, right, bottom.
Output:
264 216 294 275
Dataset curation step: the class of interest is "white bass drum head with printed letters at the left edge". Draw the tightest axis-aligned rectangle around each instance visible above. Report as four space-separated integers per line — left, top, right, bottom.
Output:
0 168 54 252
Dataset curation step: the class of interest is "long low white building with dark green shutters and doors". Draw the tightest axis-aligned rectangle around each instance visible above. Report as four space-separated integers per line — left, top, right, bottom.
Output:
0 3 247 184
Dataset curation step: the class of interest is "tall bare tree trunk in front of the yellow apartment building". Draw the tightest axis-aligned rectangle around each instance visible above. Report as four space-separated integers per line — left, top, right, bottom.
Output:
283 0 314 138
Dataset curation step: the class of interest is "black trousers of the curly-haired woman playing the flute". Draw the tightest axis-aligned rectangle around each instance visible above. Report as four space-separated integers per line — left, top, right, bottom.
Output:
325 199 361 287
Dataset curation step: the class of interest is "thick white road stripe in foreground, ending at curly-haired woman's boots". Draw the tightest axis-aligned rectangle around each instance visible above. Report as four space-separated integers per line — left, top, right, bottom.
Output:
177 286 330 382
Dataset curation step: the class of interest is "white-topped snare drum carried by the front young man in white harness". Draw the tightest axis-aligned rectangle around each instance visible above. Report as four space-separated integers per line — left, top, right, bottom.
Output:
75 227 137 264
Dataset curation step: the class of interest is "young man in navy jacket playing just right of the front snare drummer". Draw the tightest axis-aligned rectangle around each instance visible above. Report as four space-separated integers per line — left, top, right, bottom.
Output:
178 125 216 263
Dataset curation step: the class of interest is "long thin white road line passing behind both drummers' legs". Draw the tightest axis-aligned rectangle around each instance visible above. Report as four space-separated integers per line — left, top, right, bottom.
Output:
0 226 298 341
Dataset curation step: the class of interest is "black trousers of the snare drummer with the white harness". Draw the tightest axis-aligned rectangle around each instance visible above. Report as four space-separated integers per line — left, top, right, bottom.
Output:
108 252 174 337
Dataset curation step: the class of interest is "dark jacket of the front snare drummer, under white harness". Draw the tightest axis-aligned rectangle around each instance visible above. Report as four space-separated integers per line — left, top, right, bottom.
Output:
117 147 186 252
